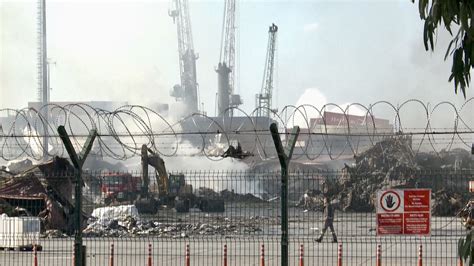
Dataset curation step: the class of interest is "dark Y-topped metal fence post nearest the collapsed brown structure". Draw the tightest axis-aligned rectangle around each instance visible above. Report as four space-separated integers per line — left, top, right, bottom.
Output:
58 126 97 266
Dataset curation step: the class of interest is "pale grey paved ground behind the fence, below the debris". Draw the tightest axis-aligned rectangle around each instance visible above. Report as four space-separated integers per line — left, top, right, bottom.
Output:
0 208 465 266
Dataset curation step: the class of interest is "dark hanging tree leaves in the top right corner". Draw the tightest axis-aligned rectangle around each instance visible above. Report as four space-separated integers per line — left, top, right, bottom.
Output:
412 0 474 97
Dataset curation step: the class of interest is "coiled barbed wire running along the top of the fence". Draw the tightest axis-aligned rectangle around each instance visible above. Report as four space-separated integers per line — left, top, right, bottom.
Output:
0 98 474 161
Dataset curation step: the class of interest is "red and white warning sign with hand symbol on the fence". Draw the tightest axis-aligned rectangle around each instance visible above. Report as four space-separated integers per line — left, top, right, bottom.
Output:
377 189 431 235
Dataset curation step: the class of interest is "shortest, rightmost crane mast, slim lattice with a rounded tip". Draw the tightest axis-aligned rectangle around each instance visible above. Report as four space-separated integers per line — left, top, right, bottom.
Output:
256 23 278 117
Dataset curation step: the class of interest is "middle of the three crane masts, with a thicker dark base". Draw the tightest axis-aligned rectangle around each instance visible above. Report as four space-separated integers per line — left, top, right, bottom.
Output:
216 0 242 115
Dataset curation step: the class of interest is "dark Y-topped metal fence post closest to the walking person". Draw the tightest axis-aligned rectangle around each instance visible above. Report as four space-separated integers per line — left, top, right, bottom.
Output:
270 123 300 266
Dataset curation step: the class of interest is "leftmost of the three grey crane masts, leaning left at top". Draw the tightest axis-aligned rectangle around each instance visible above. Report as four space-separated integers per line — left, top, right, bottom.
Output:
168 0 199 113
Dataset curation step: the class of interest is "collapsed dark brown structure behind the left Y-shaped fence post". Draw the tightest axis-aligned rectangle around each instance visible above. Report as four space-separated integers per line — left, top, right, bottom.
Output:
0 157 81 233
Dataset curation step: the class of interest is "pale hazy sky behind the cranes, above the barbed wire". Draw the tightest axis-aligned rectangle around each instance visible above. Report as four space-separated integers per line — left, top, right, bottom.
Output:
0 0 473 114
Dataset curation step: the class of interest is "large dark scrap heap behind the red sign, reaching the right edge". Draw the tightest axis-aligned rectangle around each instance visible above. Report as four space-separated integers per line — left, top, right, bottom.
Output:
298 136 474 216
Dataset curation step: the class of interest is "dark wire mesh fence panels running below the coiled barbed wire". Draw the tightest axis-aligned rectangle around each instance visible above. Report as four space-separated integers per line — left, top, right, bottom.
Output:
0 168 474 265
